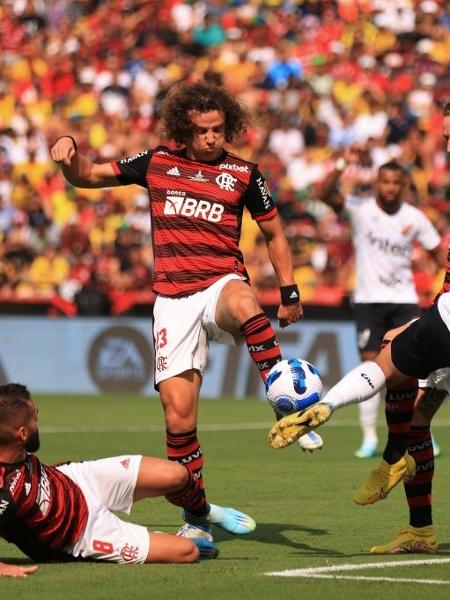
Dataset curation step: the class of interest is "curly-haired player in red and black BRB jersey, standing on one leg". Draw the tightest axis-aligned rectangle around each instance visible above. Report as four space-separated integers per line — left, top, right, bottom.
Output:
51 82 310 534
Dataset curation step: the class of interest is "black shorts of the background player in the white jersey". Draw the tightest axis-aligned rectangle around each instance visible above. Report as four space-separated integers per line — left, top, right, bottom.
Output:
354 302 421 352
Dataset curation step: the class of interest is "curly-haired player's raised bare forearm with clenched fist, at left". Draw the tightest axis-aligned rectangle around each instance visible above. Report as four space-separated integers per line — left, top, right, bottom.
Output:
50 135 121 188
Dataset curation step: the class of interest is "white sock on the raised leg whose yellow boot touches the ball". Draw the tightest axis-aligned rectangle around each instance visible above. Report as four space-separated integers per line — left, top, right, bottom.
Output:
321 360 386 410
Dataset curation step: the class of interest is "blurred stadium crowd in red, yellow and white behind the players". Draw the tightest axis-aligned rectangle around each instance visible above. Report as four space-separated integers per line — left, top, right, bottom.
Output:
0 0 450 315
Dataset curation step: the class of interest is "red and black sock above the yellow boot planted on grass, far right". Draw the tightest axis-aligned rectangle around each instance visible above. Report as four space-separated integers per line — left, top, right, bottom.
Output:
403 425 434 527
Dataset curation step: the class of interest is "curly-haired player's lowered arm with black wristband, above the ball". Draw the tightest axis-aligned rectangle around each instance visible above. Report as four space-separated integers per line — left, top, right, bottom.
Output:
258 215 303 327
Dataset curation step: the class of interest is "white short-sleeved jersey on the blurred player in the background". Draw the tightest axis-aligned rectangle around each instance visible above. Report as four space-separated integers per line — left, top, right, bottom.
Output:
345 197 440 304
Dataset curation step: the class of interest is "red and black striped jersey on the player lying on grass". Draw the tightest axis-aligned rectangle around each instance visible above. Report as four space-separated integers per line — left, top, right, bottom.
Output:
0 454 88 561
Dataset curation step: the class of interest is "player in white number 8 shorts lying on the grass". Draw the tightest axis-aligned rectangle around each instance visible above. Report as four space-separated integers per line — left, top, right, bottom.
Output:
0 384 218 577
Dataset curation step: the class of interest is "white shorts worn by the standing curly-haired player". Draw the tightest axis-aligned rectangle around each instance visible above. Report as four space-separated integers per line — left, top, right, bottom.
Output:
153 274 245 386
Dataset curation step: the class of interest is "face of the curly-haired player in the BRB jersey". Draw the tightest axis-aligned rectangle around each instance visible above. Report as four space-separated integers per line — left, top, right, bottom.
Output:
186 110 225 161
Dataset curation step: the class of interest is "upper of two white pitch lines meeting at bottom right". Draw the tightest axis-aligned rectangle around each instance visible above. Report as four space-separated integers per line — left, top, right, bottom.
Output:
265 558 450 584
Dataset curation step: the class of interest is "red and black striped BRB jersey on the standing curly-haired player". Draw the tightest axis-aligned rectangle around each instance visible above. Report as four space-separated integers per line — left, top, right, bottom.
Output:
111 148 277 297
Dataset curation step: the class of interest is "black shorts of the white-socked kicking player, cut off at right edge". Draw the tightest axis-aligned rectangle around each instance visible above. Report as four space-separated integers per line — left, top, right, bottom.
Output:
391 306 450 379
